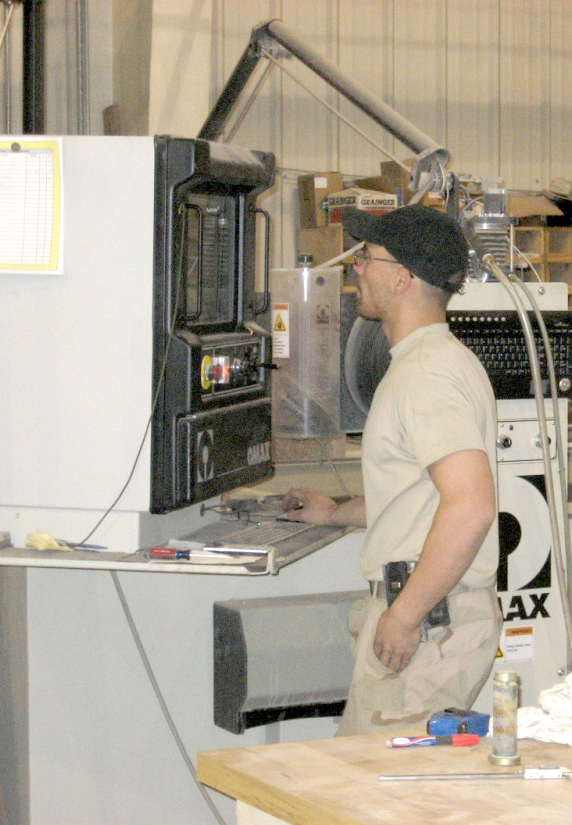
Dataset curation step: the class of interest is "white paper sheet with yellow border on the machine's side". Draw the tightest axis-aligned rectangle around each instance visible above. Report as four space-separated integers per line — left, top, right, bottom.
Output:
0 137 63 274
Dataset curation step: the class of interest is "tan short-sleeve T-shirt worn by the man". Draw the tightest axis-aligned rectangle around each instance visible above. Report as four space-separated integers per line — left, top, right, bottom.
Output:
361 324 499 588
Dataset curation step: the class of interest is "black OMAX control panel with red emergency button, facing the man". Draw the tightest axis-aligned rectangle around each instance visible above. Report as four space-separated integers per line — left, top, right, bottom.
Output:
150 136 274 513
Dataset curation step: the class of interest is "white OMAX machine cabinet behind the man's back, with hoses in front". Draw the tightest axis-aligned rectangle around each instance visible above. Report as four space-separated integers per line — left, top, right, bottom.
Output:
448 283 570 712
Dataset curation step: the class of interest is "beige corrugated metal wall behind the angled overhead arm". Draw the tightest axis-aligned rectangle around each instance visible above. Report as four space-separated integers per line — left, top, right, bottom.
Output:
212 0 572 265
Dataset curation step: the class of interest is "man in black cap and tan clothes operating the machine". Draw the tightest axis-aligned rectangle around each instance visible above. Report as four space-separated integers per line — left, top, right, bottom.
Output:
288 204 501 735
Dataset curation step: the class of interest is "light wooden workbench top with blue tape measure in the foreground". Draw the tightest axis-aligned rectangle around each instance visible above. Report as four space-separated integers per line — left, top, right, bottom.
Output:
197 733 572 825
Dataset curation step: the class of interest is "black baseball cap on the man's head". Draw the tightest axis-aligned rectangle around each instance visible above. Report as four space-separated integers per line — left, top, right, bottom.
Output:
342 203 469 292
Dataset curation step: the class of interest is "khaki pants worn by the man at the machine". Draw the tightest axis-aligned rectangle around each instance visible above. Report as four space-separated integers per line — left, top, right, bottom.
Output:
337 588 502 736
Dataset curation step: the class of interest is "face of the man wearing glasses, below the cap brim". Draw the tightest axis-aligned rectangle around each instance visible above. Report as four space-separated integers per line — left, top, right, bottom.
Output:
354 243 400 321
